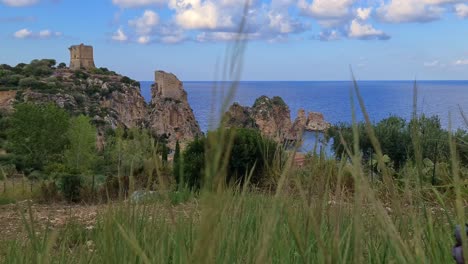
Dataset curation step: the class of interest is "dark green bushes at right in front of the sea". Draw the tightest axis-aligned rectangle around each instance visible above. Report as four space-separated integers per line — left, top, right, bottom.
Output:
327 115 460 172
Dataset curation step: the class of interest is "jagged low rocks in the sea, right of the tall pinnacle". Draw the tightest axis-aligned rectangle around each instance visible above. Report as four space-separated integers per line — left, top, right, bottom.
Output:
224 96 330 142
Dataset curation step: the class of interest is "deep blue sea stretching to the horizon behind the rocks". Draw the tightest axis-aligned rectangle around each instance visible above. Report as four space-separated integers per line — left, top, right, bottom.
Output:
141 81 468 151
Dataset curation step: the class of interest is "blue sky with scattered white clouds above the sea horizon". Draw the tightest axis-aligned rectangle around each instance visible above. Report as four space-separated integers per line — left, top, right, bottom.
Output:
0 0 468 81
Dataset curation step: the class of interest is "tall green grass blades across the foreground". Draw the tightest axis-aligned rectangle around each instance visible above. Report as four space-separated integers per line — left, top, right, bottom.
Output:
0 2 468 264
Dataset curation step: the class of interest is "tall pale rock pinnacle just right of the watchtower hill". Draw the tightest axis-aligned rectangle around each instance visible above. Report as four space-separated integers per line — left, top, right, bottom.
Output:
147 71 202 149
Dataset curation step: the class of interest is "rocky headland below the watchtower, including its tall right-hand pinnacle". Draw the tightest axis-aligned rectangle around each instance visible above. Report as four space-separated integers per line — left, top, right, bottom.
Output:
0 60 201 148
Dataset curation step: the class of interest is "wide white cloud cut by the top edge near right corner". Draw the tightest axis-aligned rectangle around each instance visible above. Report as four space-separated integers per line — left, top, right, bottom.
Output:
377 0 460 23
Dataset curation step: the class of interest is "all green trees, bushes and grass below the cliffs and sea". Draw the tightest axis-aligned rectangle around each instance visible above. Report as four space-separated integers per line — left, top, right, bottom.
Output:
0 56 468 263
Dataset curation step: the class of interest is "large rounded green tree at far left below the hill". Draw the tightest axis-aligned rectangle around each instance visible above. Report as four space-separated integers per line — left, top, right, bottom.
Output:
7 103 69 170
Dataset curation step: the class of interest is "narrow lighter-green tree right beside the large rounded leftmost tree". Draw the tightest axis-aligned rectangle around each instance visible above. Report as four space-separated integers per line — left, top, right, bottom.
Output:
64 115 97 175
